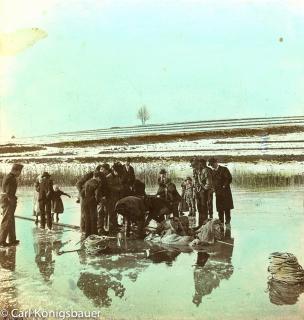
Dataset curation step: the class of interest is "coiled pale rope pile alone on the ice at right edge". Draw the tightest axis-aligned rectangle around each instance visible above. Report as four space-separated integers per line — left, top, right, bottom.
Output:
268 252 304 284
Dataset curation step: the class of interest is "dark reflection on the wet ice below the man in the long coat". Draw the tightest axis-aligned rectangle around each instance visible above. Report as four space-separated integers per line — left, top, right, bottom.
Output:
192 249 233 307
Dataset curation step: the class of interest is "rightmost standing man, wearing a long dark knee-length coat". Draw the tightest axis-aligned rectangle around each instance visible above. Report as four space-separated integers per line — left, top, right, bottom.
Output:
209 158 234 229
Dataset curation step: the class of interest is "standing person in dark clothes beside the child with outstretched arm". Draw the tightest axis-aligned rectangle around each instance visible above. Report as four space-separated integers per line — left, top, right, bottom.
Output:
35 172 54 230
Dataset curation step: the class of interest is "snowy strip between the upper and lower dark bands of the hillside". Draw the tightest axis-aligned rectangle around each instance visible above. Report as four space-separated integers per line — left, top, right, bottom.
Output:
1 131 304 161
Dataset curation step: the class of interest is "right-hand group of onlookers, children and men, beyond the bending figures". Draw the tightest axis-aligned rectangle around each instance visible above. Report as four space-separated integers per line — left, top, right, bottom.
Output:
157 158 233 228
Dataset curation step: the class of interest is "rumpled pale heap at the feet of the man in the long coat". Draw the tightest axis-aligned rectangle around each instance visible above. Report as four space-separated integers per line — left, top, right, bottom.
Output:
190 219 223 246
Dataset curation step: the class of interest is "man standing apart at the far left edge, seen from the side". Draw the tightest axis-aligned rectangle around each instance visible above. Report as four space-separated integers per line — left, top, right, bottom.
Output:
0 163 23 247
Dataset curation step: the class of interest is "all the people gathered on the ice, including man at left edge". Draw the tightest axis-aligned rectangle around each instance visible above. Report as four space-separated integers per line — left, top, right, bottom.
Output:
0 158 233 247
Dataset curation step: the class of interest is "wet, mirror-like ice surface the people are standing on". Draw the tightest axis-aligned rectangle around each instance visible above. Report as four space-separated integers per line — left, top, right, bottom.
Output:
0 189 304 319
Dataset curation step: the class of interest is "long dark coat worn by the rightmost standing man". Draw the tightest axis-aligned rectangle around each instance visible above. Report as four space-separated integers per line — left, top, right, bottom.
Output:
212 166 234 212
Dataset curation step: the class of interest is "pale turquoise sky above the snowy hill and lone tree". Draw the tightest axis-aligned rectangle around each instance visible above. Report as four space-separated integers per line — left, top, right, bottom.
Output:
0 0 304 137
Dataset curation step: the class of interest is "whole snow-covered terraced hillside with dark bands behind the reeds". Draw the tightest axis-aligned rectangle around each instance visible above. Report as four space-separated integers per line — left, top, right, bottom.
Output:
0 117 304 184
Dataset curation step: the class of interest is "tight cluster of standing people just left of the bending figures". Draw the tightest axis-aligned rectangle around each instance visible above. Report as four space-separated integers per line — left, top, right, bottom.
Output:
76 158 138 237
